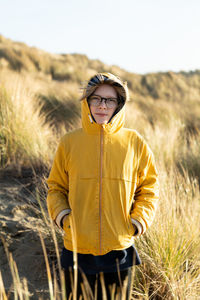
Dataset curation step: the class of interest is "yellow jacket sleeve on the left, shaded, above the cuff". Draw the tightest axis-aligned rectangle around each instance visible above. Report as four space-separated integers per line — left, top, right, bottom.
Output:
47 141 70 221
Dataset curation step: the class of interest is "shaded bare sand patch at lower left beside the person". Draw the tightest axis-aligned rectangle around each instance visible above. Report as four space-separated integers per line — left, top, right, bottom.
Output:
0 175 60 299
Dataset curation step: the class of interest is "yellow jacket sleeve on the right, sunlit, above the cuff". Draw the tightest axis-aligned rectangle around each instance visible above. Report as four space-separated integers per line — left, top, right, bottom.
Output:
131 138 159 234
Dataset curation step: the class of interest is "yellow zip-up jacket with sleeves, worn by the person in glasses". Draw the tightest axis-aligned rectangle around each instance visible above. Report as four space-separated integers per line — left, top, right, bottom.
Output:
47 95 158 255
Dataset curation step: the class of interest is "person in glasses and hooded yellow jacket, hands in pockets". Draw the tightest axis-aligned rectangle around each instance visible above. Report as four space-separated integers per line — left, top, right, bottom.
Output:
47 73 158 299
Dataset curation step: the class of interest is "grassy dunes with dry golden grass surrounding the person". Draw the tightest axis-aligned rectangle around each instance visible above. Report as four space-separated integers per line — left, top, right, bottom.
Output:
0 37 200 300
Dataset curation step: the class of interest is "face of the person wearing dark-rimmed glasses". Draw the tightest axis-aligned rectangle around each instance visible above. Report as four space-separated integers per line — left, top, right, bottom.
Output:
89 84 118 124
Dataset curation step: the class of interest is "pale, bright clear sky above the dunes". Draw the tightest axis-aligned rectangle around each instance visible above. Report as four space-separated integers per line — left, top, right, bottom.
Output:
0 0 200 74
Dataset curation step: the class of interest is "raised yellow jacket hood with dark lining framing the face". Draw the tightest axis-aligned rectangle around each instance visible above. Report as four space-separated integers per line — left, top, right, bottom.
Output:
81 73 129 134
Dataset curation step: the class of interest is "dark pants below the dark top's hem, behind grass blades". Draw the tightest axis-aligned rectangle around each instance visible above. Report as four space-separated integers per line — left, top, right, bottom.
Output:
65 268 132 300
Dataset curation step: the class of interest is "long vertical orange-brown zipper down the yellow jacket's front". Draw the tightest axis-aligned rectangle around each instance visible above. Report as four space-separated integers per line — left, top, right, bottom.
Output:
99 127 103 255
